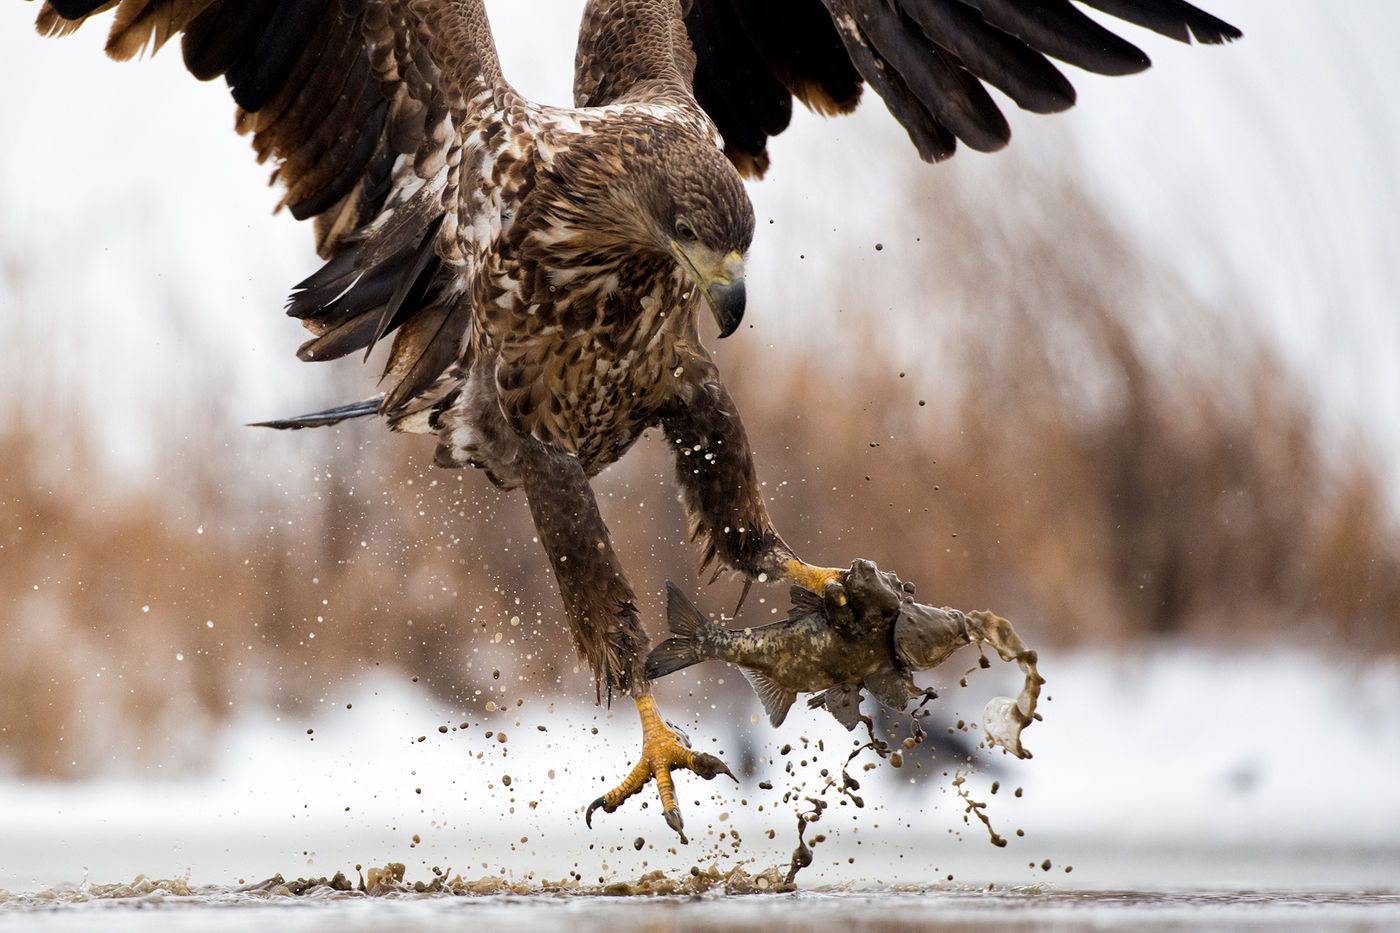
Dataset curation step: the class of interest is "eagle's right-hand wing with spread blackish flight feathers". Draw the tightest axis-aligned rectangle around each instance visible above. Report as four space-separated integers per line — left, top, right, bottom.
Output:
672 0 1240 175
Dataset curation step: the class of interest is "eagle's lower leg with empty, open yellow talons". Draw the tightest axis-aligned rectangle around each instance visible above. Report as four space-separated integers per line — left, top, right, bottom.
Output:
519 438 734 842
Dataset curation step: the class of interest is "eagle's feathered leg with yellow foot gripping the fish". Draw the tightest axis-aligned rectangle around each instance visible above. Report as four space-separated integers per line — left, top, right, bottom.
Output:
662 367 847 591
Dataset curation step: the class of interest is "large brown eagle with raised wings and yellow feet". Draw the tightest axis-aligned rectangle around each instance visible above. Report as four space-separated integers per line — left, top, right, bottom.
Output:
36 0 1240 841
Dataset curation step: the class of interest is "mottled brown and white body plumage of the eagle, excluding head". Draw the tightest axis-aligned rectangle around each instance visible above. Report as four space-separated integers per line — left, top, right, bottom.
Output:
424 95 720 473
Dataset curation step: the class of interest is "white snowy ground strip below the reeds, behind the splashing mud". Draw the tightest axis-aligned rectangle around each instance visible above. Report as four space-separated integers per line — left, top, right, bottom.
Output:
0 649 1400 891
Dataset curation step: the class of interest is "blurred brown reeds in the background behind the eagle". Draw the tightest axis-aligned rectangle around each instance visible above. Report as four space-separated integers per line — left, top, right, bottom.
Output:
0 4 1400 778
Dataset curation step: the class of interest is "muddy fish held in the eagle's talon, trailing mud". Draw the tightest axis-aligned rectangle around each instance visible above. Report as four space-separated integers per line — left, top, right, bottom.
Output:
647 560 1044 758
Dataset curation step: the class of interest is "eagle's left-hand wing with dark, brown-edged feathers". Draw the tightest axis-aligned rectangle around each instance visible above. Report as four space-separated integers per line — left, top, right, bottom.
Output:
38 0 481 424
